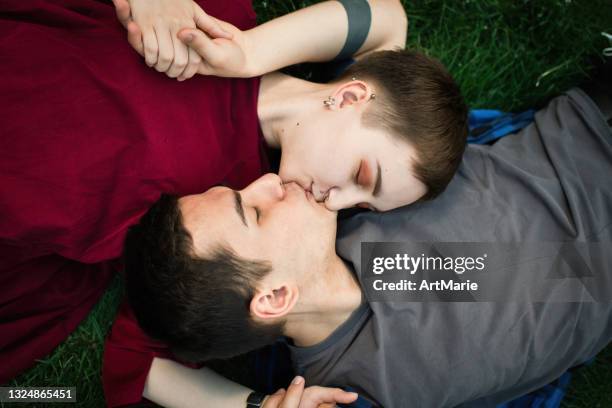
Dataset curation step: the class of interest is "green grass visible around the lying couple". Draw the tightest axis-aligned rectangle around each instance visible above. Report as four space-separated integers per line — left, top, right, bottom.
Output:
5 0 612 408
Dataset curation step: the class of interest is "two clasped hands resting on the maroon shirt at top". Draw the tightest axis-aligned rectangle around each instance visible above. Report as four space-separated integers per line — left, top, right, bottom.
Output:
113 0 255 81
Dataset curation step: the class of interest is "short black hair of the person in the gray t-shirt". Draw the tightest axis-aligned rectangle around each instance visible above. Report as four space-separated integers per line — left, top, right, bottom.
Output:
124 194 282 362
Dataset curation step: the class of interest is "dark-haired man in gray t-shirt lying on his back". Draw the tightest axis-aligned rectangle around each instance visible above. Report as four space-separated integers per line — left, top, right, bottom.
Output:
127 89 612 408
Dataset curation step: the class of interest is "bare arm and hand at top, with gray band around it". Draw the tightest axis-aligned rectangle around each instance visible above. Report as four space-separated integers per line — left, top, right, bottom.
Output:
178 0 408 77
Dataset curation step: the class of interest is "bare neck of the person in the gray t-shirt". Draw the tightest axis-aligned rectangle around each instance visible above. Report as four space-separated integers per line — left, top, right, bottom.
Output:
285 257 361 347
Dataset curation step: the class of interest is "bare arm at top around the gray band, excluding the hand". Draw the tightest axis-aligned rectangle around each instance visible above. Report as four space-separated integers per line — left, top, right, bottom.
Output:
245 0 408 75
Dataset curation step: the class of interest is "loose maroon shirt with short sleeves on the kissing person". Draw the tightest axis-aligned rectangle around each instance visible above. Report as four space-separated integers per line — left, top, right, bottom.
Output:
0 0 264 405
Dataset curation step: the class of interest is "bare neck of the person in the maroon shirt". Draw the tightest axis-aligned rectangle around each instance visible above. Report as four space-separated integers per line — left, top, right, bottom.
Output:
257 72 328 149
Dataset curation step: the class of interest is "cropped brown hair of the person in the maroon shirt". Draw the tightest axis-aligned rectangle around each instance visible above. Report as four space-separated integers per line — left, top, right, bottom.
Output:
341 50 468 200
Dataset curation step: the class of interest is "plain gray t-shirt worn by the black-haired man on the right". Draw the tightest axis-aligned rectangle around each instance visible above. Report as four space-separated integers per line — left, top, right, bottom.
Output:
291 89 612 408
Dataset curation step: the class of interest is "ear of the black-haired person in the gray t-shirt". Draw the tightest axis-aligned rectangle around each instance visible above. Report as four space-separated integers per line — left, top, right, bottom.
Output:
250 284 299 320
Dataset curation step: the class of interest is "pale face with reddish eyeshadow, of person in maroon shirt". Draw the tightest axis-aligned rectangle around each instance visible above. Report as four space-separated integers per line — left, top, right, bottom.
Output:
279 113 427 211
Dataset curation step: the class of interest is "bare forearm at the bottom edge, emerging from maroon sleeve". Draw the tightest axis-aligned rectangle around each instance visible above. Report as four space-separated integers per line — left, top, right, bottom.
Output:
143 358 251 408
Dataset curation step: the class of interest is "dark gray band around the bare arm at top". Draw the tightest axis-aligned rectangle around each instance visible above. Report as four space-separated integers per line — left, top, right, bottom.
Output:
334 0 372 61
